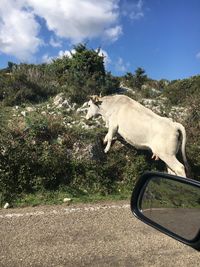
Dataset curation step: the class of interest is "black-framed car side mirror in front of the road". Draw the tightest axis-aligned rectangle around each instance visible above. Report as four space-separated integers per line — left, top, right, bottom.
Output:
131 172 200 251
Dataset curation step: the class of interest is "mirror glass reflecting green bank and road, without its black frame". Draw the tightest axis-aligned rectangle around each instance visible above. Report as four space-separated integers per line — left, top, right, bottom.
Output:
141 177 200 240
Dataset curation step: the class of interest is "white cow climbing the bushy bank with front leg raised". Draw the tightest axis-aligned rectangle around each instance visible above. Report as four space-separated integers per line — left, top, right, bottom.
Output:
86 95 189 177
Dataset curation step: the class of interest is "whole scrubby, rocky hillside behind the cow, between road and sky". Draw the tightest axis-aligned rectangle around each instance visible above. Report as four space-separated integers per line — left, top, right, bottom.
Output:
0 44 200 205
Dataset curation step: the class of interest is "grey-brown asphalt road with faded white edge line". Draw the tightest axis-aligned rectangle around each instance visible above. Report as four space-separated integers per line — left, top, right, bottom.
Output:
0 201 200 267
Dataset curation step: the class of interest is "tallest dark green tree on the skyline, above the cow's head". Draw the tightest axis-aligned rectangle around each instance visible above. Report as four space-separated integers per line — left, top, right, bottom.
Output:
58 44 119 103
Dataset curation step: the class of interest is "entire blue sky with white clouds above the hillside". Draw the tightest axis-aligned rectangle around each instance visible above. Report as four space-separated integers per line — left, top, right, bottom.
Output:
0 0 200 80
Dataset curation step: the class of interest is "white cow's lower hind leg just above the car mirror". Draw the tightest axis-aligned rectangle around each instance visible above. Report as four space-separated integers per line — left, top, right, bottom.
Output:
161 155 186 177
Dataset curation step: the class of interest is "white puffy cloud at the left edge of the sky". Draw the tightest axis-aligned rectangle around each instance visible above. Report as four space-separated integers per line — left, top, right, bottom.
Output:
0 0 43 60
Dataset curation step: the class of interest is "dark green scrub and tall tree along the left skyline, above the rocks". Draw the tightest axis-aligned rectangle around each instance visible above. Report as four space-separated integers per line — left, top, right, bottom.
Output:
0 44 119 106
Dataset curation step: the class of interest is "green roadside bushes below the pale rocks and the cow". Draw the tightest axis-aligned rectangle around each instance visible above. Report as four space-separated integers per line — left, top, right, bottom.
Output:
0 109 166 203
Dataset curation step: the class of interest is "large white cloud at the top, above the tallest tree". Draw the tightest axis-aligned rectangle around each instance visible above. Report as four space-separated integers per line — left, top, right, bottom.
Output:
26 0 119 42
